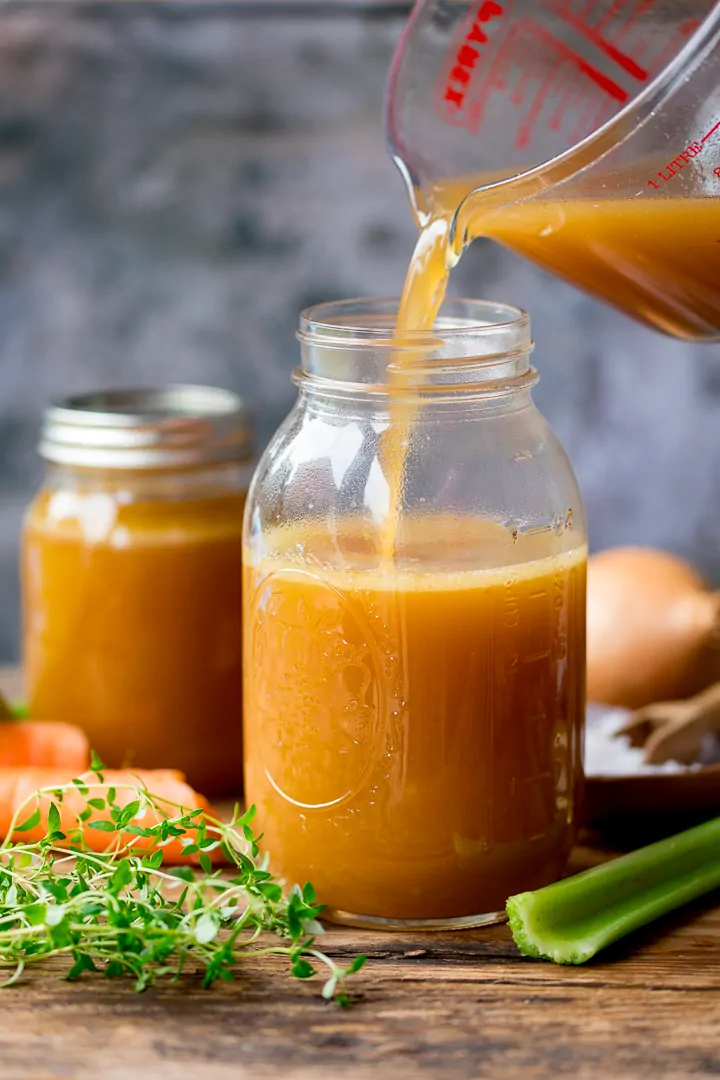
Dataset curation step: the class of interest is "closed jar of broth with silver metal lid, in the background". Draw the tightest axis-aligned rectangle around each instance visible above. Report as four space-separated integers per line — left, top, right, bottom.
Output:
22 387 253 795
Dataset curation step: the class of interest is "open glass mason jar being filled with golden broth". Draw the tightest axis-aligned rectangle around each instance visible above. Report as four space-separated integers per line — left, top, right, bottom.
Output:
244 300 586 928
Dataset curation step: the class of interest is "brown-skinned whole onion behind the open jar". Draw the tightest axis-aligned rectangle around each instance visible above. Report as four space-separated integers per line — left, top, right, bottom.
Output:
587 548 720 708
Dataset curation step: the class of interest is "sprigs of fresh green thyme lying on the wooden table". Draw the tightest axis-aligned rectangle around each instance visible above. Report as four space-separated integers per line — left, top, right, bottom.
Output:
0 757 365 1004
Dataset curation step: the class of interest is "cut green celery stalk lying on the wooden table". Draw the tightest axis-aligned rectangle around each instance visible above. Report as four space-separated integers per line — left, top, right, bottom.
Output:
507 818 720 963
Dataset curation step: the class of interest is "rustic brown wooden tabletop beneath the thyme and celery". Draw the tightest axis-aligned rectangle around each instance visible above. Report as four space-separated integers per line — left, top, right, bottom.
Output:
0 665 720 1080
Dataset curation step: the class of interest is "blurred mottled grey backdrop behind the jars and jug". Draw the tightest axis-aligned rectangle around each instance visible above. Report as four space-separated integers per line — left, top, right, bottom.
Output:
0 0 720 661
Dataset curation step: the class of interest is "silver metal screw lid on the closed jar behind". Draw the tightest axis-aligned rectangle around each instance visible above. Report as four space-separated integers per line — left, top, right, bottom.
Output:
39 386 253 470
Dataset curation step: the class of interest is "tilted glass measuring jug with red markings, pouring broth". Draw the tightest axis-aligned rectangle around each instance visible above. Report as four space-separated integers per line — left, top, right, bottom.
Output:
386 0 720 341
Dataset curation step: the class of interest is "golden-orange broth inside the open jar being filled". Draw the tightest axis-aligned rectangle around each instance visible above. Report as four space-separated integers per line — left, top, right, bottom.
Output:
244 517 585 919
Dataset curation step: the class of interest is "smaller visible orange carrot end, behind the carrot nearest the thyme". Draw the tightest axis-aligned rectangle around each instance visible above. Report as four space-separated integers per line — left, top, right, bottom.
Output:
0 720 90 775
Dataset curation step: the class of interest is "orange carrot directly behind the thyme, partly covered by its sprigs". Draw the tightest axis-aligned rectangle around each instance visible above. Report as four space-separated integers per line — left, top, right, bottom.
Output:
0 768 214 865
